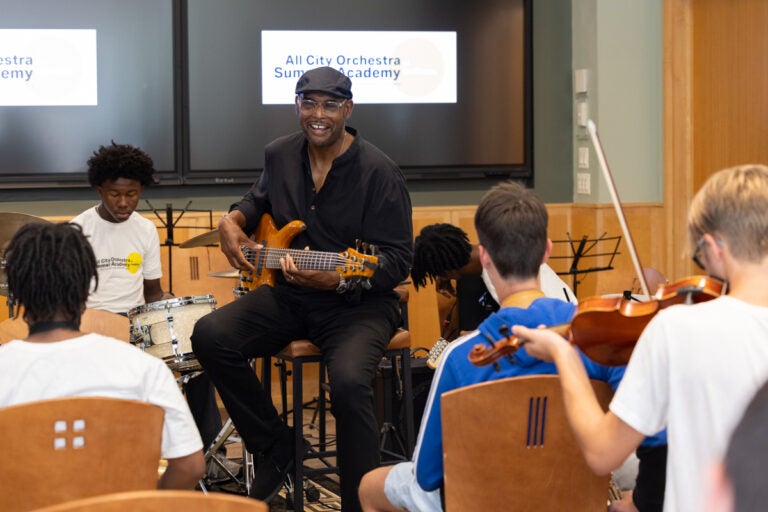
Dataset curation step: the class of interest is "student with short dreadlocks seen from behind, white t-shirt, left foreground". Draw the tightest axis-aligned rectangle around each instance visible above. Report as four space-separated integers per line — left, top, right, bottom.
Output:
0 223 205 489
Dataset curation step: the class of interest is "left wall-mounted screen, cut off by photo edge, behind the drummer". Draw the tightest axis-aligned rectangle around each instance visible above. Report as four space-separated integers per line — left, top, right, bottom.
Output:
0 0 179 187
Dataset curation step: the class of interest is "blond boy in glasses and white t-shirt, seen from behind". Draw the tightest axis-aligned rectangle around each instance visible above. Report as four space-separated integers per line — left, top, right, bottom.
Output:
513 165 768 512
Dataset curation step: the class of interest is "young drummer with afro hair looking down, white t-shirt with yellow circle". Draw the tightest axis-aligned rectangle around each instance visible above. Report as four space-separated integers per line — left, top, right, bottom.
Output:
72 141 234 480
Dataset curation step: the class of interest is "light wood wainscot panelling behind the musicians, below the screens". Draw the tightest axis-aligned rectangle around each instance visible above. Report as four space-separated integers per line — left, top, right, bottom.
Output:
21 204 664 348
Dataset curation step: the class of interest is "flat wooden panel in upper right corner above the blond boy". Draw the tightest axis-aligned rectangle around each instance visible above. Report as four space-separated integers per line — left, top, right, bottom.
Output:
693 0 768 184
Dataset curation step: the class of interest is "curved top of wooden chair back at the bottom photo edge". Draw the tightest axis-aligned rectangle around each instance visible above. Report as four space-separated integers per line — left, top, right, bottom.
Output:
30 490 269 512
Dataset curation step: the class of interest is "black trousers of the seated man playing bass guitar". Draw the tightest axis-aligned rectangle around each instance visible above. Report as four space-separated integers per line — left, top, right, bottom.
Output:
192 284 400 511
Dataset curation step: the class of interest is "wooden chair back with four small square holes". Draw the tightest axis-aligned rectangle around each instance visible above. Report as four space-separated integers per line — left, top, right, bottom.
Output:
0 397 165 512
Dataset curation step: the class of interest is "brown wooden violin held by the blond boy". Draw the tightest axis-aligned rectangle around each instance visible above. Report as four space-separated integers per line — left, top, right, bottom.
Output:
469 276 726 366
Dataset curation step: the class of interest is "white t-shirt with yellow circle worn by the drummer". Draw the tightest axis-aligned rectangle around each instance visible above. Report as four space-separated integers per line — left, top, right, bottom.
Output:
72 207 163 313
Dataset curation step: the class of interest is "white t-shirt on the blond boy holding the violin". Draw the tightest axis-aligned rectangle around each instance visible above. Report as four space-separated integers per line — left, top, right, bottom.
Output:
610 296 768 512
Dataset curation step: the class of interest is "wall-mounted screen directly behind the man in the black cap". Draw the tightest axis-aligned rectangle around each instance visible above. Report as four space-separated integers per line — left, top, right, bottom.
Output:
186 0 532 183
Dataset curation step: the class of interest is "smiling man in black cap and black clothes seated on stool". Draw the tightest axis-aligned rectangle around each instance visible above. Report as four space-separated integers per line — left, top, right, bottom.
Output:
191 67 413 511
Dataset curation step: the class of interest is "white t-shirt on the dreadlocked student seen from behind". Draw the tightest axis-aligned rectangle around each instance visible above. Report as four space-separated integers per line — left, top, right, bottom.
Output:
0 334 203 459
